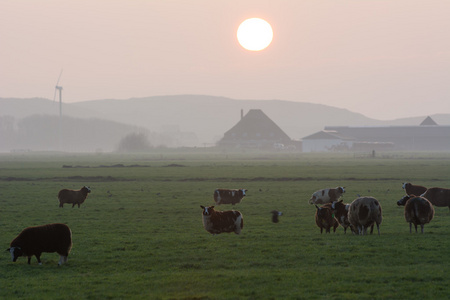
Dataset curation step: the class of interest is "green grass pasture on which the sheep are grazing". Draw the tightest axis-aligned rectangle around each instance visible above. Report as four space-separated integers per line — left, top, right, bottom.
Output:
0 150 450 299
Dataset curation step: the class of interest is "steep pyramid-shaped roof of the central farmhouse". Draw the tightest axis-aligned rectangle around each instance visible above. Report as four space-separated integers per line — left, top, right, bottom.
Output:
219 109 291 145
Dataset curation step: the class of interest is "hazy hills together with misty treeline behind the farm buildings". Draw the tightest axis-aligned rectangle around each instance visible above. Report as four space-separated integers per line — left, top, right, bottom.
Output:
0 95 450 152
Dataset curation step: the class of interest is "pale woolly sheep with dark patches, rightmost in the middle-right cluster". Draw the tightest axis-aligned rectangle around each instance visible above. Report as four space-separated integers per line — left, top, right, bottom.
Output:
348 197 383 235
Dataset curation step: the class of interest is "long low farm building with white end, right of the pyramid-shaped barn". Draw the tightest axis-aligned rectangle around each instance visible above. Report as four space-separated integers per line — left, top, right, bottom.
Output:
303 117 450 152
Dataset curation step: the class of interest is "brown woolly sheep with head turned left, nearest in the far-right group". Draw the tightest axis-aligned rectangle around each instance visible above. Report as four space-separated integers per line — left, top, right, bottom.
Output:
397 195 434 233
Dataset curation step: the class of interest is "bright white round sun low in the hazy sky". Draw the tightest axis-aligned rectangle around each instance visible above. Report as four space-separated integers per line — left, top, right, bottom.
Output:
237 18 273 51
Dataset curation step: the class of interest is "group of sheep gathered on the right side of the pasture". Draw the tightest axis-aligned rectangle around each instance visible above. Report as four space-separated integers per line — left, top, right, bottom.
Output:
309 182 450 235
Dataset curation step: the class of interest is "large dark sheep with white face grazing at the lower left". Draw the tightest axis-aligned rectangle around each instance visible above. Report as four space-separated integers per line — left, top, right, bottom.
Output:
6 223 72 265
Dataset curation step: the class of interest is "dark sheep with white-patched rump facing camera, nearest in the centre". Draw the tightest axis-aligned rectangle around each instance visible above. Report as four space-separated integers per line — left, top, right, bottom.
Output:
200 205 244 234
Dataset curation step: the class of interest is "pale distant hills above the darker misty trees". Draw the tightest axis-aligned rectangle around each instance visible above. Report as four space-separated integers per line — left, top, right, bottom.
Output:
0 95 450 146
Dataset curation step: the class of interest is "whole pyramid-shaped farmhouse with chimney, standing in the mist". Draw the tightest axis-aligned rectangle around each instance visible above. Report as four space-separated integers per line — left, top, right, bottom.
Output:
217 109 293 149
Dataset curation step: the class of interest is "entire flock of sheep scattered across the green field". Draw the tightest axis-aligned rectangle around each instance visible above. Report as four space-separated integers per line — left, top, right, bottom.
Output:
7 183 450 265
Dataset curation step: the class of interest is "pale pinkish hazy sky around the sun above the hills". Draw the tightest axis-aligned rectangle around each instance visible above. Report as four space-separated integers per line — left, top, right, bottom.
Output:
0 0 450 120
